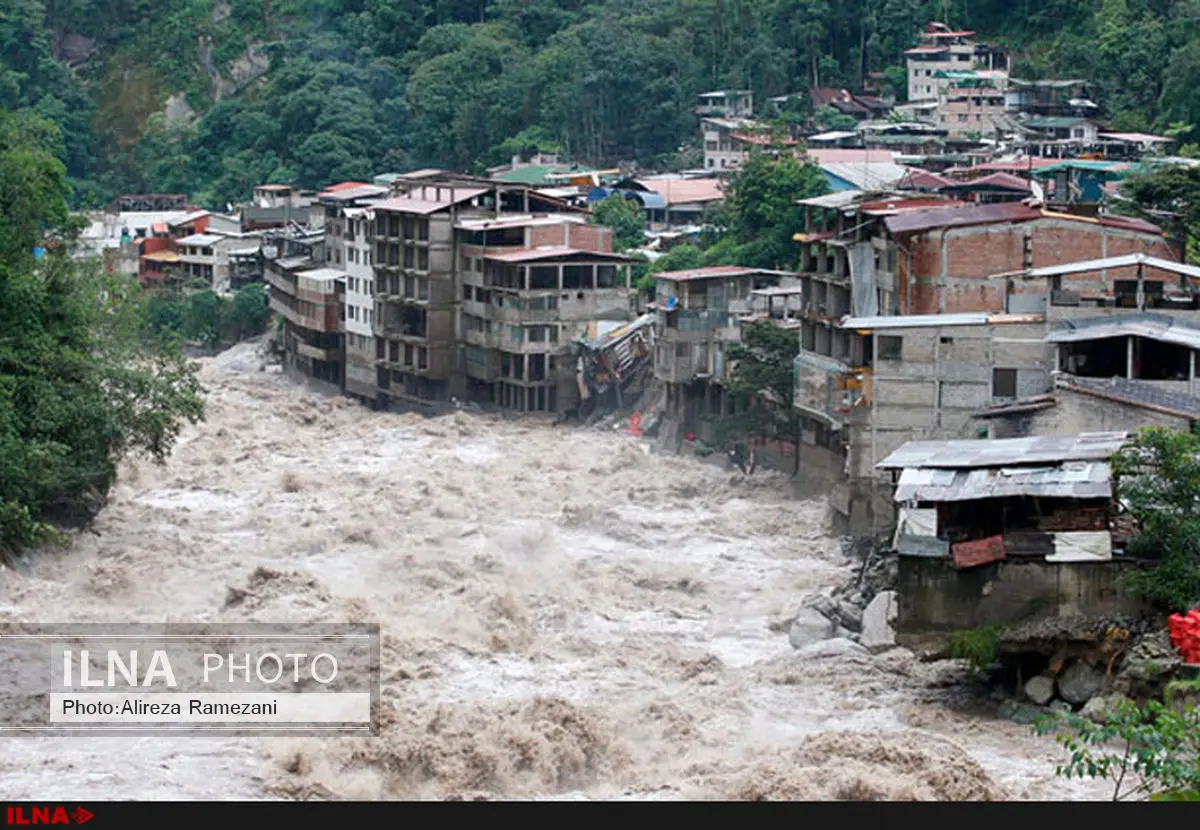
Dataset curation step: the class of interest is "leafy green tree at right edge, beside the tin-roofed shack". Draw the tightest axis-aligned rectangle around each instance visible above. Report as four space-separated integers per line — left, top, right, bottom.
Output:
1112 427 1200 612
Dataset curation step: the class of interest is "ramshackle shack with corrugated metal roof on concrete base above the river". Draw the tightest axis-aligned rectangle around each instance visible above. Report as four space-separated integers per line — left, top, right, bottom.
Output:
877 432 1140 651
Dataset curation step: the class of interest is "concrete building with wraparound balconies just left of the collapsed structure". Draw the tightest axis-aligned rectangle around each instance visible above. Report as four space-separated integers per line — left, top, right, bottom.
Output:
455 216 634 411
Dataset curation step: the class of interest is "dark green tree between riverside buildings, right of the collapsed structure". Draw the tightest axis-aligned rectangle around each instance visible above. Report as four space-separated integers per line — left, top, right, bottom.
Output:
718 321 800 475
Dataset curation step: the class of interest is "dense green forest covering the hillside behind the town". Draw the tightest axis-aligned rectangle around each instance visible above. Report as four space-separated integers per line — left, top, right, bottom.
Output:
7 0 1200 206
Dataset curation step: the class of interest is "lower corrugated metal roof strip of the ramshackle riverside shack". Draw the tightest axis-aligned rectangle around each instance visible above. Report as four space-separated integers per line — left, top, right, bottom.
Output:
894 461 1112 503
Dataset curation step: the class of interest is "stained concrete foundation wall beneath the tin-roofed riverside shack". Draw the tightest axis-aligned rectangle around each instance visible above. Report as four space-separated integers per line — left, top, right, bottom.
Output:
896 557 1139 637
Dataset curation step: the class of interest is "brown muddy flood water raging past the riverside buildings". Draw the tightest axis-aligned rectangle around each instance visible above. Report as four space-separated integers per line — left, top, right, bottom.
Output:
0 345 1108 800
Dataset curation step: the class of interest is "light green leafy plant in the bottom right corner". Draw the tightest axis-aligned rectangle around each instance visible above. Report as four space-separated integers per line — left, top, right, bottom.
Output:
1033 699 1200 801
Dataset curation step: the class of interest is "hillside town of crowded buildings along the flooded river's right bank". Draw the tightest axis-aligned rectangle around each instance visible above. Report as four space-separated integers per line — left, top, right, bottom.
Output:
51 16 1200 796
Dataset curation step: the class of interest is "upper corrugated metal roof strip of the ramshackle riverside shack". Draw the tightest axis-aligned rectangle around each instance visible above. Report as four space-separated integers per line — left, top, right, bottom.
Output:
875 432 1129 470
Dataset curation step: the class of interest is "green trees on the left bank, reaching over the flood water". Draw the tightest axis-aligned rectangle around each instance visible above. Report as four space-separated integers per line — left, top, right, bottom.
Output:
0 113 203 558
